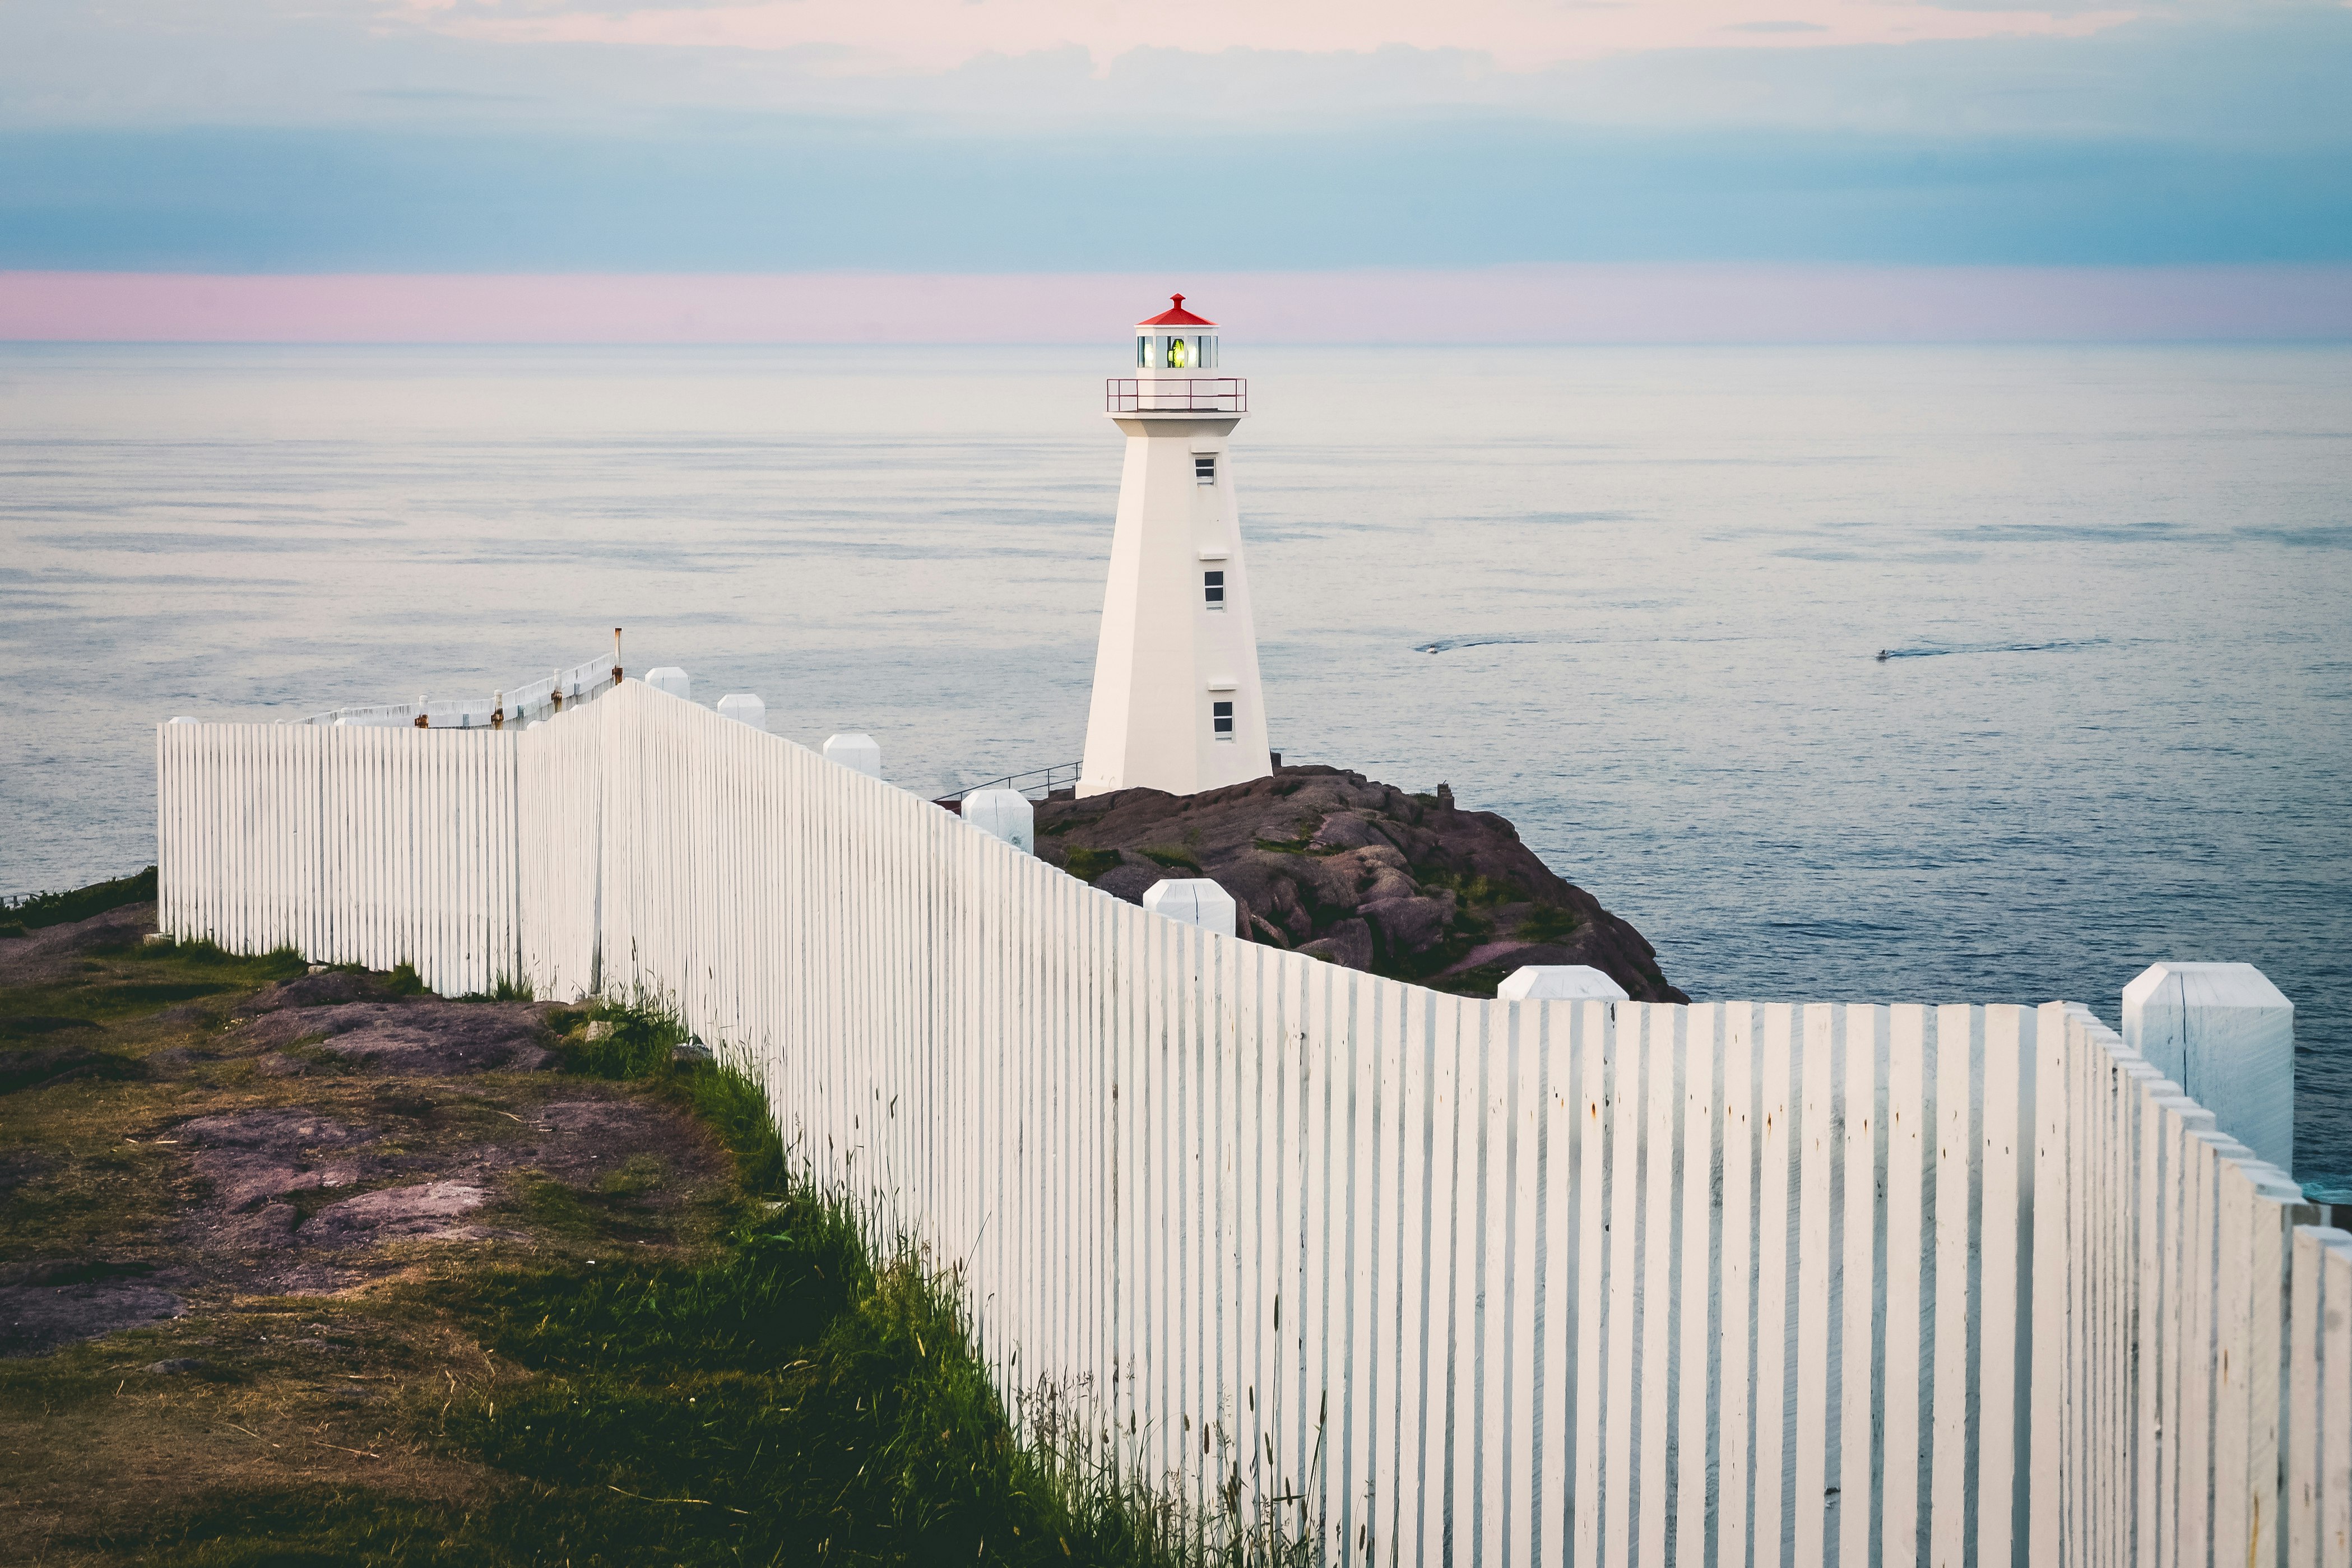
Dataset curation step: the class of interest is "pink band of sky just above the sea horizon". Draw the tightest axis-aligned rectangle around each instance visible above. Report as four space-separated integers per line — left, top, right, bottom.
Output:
0 263 2352 343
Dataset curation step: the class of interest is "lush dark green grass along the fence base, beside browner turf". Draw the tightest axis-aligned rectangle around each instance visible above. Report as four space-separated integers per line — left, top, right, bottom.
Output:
122 1029 1204 1568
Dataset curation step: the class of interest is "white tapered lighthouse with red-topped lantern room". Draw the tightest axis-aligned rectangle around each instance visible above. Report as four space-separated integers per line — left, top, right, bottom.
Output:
1077 294 1273 795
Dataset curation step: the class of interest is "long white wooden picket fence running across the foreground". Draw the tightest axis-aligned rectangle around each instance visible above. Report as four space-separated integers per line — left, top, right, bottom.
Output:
157 682 2352 1568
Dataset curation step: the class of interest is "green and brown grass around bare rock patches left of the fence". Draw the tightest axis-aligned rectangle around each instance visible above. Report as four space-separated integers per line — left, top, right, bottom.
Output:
0 884 1301 1568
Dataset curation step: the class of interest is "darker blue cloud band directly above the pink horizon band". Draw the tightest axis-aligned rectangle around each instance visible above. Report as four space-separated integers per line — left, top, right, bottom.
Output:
0 120 2352 273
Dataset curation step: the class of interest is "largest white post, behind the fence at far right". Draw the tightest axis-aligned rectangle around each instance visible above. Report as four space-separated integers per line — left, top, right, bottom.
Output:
2124 964 2295 1171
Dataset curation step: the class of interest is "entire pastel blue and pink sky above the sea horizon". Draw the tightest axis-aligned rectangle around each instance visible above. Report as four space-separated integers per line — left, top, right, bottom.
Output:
0 0 2352 338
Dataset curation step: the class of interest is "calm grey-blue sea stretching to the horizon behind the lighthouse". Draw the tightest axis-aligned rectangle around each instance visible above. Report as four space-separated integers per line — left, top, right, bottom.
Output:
0 345 2352 1196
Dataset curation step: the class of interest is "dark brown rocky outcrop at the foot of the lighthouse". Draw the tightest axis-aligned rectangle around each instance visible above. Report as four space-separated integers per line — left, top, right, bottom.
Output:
1037 767 1688 1001
